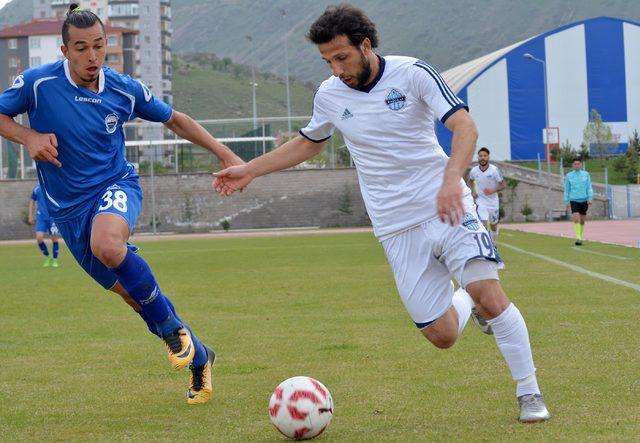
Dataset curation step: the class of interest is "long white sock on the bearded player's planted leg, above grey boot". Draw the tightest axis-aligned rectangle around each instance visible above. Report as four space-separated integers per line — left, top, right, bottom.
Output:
487 303 540 393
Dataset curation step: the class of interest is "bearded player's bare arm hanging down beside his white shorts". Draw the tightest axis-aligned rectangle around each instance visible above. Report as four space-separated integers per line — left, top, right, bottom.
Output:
438 109 478 226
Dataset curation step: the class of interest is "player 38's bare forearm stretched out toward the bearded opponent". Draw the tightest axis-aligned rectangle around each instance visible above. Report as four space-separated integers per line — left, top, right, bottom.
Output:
165 110 244 169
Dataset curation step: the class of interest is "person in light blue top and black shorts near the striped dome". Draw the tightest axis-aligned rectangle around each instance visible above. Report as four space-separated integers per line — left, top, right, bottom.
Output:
564 158 593 246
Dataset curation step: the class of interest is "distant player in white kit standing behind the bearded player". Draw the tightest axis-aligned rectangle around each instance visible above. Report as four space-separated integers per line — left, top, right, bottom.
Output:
469 148 506 243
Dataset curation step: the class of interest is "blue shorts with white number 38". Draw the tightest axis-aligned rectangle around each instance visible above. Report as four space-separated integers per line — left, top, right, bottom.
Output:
58 176 142 289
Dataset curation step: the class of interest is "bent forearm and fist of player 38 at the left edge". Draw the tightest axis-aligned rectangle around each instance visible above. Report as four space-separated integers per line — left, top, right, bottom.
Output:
0 114 62 167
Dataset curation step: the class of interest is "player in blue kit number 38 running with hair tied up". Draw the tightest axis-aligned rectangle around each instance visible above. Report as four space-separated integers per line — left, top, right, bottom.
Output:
0 4 243 404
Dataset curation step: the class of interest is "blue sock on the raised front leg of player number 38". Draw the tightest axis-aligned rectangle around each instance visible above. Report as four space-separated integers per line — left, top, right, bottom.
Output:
112 250 182 336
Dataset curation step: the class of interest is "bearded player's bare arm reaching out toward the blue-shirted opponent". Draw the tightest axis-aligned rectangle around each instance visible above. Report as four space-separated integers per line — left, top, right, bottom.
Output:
213 136 326 195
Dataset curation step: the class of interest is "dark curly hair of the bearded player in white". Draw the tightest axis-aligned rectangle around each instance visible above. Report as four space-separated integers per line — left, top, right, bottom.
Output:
307 3 378 48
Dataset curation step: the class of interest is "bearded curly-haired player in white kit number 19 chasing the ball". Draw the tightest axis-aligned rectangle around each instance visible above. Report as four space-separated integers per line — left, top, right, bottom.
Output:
214 4 549 422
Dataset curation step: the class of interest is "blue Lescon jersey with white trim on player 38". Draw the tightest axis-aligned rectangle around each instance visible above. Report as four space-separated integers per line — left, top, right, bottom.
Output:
0 60 173 220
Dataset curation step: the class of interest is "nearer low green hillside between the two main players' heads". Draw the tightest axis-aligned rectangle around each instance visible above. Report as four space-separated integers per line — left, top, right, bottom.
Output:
173 55 313 119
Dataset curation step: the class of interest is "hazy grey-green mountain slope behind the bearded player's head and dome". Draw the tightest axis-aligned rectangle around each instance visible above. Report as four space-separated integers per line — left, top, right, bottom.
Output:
172 0 640 83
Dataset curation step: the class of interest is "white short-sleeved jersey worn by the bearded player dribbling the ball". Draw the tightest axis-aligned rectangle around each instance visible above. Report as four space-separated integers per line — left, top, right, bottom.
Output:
300 56 471 239
